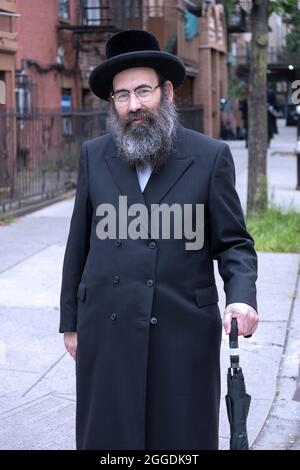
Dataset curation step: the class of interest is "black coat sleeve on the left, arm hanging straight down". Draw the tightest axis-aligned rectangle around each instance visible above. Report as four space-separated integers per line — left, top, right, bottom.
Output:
59 144 92 333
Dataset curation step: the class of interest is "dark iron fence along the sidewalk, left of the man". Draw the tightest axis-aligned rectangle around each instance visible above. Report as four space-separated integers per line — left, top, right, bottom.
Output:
0 111 107 211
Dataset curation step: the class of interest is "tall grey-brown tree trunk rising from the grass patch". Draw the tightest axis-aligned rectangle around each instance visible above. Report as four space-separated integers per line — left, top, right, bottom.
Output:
247 0 268 214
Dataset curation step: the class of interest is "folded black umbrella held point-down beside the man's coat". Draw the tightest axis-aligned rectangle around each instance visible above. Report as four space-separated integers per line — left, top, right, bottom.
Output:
225 318 251 450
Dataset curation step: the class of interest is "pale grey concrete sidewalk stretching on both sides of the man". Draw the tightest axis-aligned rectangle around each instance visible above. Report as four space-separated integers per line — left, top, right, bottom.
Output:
0 120 300 449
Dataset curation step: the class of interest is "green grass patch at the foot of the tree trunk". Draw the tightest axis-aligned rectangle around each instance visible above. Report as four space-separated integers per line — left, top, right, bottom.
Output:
246 207 300 253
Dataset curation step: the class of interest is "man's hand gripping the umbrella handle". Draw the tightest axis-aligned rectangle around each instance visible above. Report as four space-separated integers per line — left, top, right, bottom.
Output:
223 303 258 336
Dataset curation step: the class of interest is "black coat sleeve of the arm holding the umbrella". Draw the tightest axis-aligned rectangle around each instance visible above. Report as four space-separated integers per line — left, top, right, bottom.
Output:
209 144 257 310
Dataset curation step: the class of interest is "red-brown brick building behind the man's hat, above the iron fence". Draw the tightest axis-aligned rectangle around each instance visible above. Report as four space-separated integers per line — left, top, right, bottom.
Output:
10 0 227 137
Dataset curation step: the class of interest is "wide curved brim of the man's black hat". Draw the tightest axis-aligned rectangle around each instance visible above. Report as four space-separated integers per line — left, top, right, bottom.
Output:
89 51 185 100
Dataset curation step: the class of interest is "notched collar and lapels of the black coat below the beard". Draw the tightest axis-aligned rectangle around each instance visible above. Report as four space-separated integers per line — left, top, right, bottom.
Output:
105 124 194 209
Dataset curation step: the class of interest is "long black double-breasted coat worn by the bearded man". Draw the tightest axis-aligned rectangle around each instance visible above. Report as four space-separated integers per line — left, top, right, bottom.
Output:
60 125 257 450
